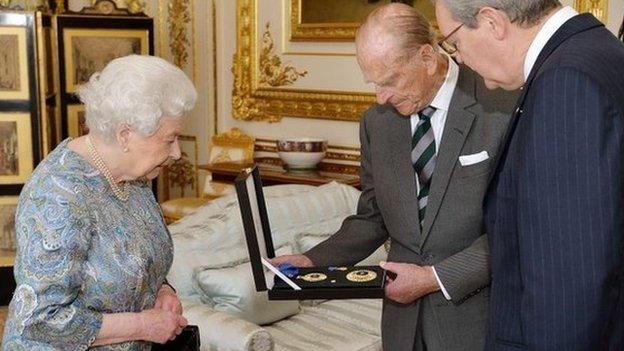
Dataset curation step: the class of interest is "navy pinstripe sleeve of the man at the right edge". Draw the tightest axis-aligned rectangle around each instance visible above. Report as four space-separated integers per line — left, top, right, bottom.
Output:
516 68 624 350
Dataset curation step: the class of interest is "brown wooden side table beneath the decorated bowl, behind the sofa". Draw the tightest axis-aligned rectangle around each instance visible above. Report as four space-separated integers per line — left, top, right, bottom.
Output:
199 160 360 188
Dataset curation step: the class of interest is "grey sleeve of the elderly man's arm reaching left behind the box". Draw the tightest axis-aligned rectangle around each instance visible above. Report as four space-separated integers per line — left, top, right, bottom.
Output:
305 115 388 266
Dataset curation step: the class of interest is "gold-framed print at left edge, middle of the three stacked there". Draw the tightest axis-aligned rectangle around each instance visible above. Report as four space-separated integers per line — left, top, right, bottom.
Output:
0 112 33 184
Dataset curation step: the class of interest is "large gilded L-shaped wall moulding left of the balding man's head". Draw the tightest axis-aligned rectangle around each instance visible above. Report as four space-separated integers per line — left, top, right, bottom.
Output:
232 0 375 122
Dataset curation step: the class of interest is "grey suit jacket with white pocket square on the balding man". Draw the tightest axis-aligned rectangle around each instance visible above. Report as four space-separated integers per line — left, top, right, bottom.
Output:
306 66 517 351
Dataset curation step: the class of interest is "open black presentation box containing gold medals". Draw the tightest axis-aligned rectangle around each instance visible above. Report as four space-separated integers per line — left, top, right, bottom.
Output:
235 166 386 300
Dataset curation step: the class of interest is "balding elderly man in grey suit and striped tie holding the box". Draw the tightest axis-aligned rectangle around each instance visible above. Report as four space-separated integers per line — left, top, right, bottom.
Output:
273 4 516 351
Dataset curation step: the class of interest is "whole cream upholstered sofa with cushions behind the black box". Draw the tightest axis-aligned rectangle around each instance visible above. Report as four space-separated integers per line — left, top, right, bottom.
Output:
167 183 386 351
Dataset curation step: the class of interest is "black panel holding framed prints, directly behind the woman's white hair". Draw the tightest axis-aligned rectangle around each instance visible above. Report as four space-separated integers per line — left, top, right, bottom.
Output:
56 14 154 138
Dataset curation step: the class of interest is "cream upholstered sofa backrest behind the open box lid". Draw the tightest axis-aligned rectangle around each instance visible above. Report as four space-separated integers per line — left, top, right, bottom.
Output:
167 182 359 298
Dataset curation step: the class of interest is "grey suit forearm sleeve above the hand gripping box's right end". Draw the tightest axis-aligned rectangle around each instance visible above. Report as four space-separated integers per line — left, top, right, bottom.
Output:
434 234 490 304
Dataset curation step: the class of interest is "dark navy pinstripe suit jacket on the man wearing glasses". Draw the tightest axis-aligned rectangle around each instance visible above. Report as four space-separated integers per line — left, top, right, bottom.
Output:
485 14 624 351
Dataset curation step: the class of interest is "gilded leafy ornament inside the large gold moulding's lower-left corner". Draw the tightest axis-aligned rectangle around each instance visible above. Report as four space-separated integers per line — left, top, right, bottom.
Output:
259 22 308 87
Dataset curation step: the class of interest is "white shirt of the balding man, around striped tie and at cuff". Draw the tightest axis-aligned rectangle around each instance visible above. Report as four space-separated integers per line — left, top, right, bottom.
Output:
410 54 459 300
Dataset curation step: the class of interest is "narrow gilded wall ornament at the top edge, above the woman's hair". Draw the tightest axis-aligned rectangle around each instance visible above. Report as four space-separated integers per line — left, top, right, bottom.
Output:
167 0 191 68
